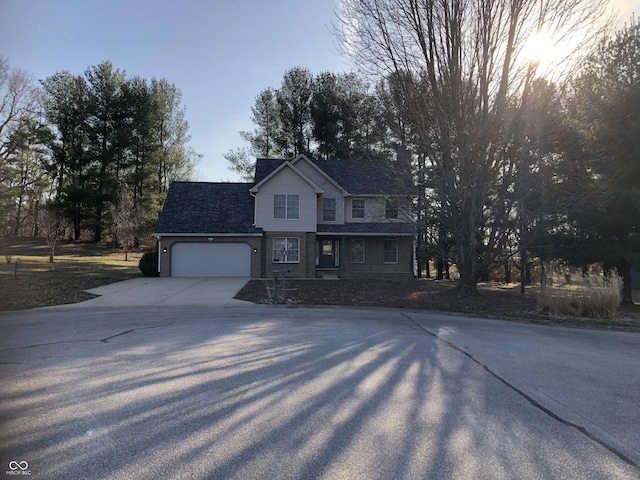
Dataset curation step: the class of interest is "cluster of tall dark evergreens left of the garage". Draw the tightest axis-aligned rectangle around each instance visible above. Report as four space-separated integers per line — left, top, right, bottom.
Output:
42 62 198 242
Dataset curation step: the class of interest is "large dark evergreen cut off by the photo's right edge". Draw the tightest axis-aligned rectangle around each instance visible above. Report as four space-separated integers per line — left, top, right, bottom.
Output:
569 23 640 302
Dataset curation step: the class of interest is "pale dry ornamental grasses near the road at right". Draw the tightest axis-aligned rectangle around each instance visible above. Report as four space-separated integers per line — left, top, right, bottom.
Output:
538 273 622 319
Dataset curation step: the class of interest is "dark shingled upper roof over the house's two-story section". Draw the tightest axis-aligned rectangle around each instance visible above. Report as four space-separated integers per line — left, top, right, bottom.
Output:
255 158 415 195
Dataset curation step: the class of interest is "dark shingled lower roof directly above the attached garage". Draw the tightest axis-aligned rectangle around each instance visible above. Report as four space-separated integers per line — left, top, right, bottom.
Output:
154 182 262 234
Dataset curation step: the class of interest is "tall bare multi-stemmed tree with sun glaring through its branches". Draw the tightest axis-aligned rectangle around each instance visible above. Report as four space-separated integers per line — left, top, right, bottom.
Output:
336 0 606 296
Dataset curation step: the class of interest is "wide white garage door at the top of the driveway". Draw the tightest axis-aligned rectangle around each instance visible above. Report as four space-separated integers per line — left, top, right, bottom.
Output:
171 243 251 277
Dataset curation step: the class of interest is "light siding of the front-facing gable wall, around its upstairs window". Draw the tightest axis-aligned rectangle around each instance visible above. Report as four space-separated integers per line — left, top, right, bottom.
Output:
255 168 318 232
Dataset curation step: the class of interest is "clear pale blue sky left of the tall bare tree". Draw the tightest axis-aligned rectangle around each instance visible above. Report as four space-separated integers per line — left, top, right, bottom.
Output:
0 0 640 181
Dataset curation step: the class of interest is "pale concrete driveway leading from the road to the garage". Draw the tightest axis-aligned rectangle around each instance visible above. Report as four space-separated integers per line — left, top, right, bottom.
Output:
64 277 251 308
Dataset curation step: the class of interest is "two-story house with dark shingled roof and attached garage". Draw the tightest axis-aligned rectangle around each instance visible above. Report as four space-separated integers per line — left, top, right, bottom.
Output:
155 155 415 278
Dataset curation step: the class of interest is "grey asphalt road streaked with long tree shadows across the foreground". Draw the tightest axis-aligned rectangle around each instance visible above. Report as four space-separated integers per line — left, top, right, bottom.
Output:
0 306 640 480
